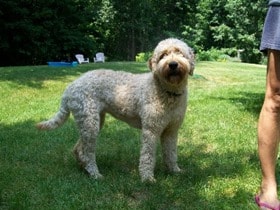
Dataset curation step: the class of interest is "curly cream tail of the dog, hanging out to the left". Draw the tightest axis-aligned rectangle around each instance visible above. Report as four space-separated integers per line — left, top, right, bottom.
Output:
36 98 70 130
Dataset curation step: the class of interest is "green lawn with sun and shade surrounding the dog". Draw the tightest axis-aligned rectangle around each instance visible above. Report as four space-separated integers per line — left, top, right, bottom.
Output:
0 62 270 210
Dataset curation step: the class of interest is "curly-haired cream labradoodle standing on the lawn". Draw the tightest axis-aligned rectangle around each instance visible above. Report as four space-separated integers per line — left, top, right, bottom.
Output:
37 38 194 182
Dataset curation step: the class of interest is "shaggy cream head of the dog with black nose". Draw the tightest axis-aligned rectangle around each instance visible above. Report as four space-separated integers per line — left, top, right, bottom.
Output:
149 38 194 85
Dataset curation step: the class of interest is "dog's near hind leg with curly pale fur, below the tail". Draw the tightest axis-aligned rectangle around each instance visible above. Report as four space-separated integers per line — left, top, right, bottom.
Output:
74 110 102 179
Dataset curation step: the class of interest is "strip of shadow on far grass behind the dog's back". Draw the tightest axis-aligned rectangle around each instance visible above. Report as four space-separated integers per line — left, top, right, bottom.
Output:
0 62 148 88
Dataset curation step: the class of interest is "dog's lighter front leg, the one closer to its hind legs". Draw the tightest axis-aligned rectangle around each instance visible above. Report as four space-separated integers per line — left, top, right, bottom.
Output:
139 129 157 182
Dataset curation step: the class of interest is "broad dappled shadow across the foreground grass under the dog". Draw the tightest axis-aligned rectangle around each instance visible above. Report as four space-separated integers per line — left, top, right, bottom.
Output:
0 118 258 209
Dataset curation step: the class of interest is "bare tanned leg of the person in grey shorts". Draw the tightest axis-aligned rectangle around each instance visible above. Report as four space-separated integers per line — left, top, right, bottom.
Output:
258 50 280 207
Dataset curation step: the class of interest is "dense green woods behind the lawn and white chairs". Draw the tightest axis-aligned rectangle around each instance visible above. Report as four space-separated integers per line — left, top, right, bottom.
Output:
0 0 266 66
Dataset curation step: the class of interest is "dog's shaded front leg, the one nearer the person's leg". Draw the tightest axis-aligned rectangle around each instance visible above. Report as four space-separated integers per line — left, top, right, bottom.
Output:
161 129 181 172
